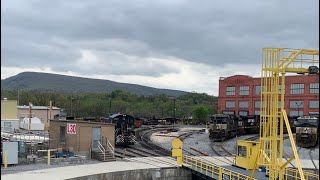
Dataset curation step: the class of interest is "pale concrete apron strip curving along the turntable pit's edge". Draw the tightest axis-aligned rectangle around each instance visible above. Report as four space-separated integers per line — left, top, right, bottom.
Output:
1 157 176 180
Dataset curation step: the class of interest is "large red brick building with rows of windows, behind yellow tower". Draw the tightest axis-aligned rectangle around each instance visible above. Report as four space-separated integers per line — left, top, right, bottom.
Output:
218 75 319 116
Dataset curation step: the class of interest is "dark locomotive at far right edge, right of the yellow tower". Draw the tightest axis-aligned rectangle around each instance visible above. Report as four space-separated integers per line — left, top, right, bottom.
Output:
296 116 319 148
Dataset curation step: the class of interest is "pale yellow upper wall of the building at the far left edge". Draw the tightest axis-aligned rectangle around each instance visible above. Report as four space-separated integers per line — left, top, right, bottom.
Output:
1 100 18 119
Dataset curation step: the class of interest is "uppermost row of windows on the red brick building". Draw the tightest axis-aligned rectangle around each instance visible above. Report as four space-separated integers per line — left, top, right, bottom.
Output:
226 83 319 96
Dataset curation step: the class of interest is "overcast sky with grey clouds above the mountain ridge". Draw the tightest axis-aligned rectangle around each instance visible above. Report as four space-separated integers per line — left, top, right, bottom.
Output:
1 0 319 96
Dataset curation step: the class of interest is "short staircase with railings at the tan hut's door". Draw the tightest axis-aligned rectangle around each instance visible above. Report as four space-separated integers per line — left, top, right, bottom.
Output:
91 140 116 162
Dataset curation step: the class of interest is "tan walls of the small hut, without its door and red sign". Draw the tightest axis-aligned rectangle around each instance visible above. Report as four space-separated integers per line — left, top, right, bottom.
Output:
49 120 115 156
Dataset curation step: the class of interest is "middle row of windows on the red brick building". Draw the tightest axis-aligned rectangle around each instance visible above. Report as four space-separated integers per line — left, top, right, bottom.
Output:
226 100 319 108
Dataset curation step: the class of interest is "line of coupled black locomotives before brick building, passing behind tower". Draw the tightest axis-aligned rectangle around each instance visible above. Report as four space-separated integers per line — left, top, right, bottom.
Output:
209 114 297 141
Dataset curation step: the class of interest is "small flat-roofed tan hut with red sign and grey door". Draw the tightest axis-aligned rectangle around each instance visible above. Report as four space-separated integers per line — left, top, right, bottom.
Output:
49 120 115 157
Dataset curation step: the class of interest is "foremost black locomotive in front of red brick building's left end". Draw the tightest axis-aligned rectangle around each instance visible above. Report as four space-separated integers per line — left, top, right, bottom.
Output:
209 114 238 141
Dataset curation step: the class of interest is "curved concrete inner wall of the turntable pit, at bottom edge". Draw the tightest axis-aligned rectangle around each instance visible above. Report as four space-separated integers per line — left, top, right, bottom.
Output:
69 168 192 180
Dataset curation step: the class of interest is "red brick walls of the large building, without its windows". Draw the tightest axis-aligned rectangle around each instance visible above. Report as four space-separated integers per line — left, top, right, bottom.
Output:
218 75 319 115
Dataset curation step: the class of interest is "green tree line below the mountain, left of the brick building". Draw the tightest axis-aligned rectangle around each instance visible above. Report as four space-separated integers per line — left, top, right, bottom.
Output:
1 90 217 123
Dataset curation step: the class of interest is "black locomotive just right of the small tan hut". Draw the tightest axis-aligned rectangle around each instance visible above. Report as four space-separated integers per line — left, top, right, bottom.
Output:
101 114 136 146
